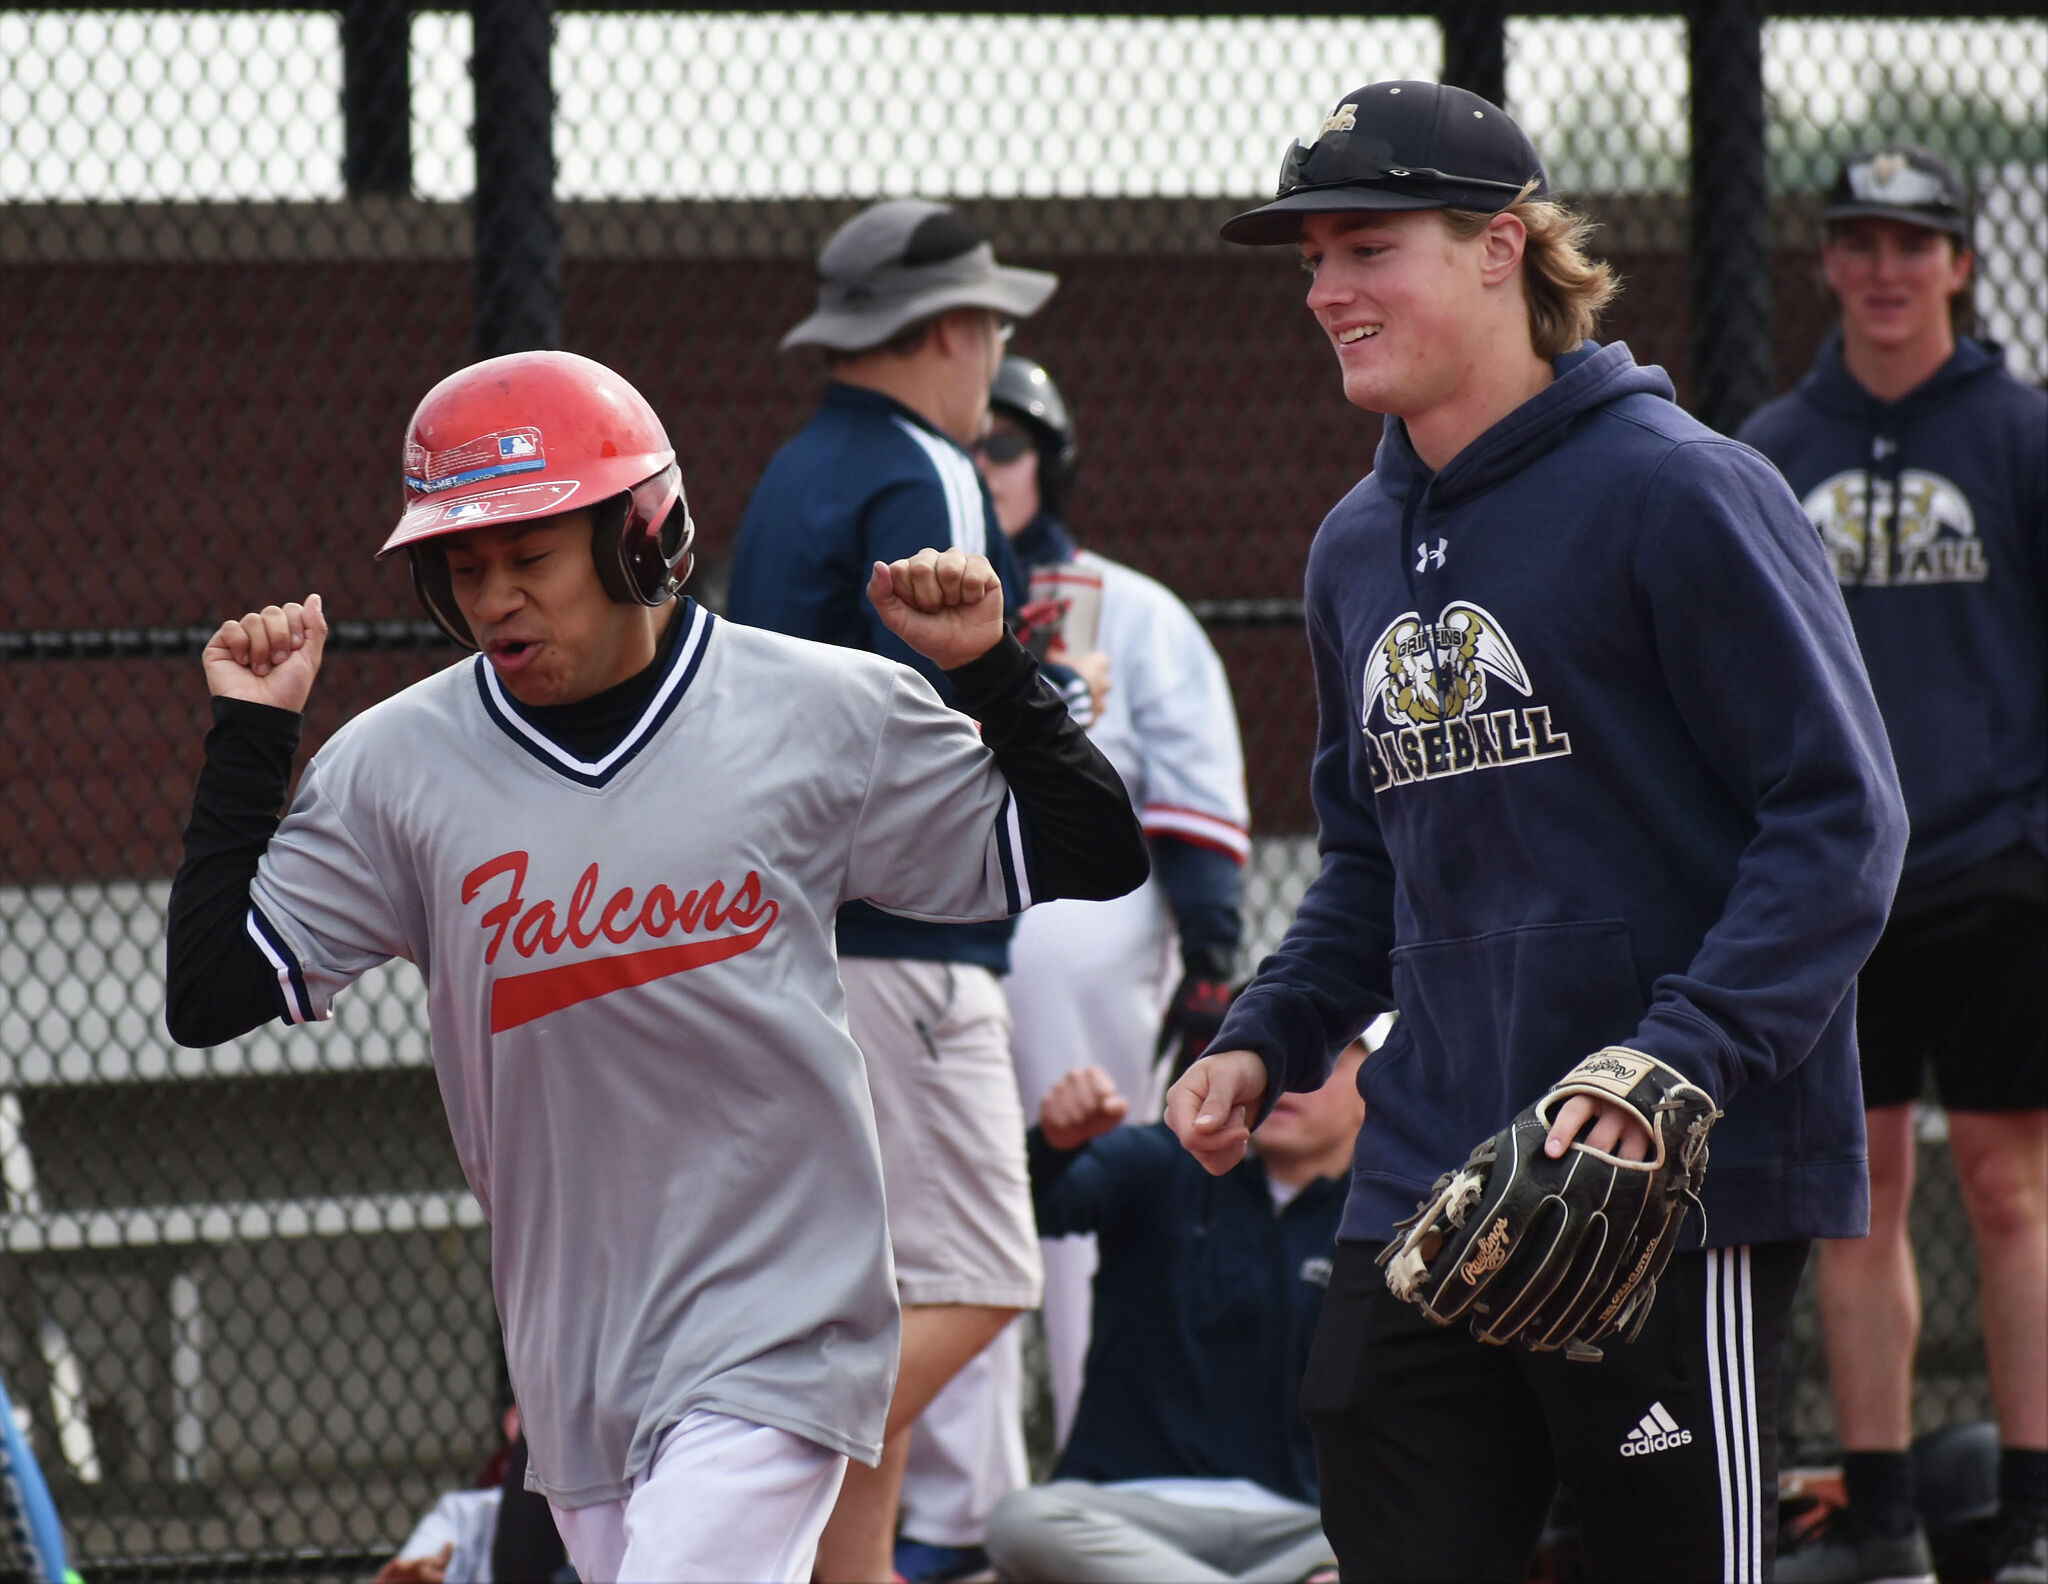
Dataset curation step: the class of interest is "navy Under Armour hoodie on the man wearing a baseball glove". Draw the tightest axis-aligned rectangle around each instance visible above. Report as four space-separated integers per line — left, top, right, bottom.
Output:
1210 342 1907 1246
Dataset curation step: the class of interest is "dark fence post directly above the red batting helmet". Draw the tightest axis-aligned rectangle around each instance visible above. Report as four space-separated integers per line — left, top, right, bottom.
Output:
471 0 561 357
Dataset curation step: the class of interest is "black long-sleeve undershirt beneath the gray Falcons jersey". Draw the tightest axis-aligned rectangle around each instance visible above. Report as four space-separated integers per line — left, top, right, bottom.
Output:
164 633 1149 1047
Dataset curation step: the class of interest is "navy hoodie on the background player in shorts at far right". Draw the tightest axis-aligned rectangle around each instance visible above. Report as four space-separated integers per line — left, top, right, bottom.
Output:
1741 332 2048 920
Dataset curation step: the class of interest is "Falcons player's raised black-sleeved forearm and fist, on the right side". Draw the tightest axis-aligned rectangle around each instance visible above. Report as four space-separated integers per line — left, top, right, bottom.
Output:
868 549 1151 906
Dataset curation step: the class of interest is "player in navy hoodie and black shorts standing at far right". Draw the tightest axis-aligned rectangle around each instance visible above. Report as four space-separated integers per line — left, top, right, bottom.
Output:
1741 143 2048 1582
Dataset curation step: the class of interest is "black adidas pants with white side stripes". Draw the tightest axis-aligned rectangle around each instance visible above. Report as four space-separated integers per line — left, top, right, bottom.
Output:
1300 1242 1808 1584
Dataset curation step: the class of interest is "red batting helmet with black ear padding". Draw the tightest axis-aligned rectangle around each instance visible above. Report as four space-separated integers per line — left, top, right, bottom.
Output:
377 352 696 650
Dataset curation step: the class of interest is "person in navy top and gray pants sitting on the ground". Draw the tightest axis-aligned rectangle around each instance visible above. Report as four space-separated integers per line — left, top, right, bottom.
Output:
987 1043 1366 1584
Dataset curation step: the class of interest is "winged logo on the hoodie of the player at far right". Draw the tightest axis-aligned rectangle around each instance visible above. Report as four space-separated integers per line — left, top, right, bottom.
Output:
1800 467 1989 588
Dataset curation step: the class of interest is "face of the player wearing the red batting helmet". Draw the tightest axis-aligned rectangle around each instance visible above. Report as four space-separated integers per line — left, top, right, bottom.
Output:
444 510 668 705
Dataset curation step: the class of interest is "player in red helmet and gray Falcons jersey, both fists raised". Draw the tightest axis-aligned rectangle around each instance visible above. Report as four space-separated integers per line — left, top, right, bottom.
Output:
168 352 1147 1582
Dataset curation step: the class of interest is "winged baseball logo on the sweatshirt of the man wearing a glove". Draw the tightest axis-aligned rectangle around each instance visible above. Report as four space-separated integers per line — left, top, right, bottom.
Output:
1364 600 1571 793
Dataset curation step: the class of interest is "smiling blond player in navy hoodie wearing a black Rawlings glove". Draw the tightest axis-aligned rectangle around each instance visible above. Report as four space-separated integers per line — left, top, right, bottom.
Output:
1167 82 1905 1580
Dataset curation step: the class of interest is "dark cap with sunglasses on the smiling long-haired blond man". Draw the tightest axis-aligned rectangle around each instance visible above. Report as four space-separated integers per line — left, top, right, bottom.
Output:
1223 82 1550 246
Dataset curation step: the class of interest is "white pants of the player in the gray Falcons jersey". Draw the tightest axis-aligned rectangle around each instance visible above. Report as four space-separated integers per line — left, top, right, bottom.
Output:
549 1408 846 1584
